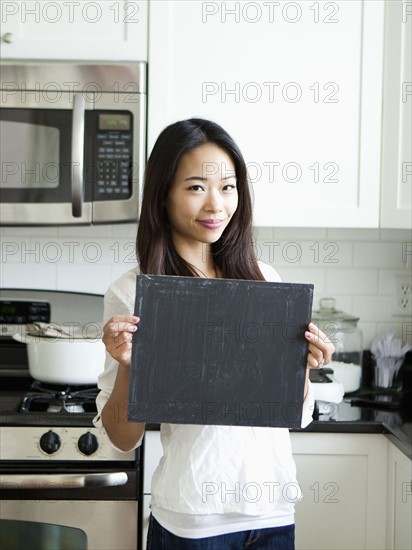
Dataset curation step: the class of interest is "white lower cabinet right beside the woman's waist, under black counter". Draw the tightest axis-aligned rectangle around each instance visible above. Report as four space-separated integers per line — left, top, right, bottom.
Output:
291 433 388 550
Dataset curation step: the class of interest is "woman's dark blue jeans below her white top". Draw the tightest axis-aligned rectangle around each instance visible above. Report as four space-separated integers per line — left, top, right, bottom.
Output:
147 515 295 550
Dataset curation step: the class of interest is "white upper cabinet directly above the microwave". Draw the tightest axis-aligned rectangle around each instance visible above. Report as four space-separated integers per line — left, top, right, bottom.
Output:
0 0 147 61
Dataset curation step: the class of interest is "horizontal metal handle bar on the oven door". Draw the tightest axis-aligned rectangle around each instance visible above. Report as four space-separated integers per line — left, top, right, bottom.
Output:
0 472 129 490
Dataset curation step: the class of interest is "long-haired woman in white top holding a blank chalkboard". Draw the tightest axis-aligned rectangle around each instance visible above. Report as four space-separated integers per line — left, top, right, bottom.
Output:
95 119 334 550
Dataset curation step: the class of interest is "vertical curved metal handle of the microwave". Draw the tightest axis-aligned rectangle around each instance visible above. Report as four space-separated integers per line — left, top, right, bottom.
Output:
71 94 86 218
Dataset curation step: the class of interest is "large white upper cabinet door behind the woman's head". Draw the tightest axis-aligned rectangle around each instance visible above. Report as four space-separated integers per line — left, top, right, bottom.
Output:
149 0 384 227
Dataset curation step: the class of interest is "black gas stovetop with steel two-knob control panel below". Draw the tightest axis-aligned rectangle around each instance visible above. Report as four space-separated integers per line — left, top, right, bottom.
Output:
0 377 135 462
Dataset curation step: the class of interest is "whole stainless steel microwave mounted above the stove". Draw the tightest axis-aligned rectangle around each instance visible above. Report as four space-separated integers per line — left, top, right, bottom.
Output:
0 62 147 226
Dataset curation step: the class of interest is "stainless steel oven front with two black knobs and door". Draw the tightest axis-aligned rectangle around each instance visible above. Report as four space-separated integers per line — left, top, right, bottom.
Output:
0 425 139 550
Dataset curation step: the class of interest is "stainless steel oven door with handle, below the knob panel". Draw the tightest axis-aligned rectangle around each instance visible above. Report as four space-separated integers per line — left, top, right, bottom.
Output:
0 464 138 550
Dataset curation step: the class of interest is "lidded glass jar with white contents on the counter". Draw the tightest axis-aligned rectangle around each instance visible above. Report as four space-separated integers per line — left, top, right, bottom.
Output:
312 298 363 393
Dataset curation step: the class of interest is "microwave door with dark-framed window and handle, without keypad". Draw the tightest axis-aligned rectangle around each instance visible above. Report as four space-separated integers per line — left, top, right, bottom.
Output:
0 91 93 226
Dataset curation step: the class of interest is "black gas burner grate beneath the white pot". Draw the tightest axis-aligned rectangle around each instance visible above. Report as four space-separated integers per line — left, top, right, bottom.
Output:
20 382 99 414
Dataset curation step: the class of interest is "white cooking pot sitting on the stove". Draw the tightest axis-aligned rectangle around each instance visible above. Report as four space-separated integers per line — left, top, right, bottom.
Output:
13 334 105 385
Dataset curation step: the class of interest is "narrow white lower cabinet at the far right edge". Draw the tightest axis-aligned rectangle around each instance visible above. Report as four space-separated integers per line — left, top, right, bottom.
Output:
386 443 412 550
